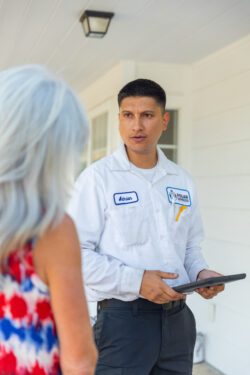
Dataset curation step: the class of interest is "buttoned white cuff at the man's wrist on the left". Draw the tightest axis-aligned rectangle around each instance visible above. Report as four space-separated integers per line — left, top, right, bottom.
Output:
120 266 144 298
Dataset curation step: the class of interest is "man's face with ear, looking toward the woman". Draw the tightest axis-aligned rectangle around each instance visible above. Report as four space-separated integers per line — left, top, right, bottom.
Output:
119 96 169 153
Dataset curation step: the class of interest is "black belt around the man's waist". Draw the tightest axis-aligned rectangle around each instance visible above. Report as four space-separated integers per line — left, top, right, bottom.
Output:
97 298 186 311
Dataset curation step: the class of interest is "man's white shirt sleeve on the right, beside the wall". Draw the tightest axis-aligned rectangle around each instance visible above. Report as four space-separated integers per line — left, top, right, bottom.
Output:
184 182 208 282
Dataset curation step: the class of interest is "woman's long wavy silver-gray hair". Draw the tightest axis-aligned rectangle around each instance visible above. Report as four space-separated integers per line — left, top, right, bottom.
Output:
0 65 88 262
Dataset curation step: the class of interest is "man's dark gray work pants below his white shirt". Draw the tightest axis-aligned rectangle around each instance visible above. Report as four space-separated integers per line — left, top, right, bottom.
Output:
94 299 196 375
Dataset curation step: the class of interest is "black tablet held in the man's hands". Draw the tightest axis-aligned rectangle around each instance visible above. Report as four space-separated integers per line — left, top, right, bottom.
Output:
173 273 246 293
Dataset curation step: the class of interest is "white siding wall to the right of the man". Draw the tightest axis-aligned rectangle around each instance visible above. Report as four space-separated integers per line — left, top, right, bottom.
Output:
189 37 250 375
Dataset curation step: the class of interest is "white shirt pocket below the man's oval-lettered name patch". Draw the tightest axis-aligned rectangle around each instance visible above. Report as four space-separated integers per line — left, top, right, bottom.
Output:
110 206 149 246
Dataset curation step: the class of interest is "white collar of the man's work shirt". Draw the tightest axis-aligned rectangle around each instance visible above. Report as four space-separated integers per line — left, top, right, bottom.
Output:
110 144 178 175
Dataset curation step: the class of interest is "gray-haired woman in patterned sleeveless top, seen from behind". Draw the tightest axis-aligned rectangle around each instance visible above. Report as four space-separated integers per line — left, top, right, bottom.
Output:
0 65 97 375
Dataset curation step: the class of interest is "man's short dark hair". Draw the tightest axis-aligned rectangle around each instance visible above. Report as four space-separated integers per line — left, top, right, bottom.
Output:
118 78 166 112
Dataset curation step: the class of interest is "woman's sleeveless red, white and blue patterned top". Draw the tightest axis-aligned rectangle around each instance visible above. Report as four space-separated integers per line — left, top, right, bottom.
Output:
0 242 61 375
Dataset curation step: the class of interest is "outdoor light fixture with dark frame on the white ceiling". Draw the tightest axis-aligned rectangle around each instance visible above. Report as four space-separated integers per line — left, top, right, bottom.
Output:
79 10 114 38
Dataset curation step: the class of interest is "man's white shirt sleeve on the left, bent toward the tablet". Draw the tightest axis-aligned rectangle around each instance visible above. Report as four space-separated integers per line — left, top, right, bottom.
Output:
68 169 144 300
